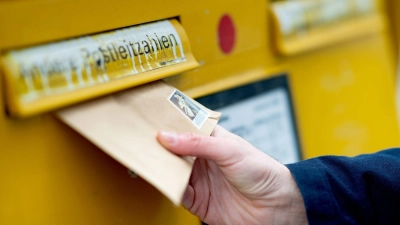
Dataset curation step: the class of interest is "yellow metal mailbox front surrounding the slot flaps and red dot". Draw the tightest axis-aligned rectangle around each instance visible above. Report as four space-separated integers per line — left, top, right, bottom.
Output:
0 0 400 225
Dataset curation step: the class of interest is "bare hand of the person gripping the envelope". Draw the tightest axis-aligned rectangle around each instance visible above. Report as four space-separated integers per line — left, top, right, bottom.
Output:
157 126 308 225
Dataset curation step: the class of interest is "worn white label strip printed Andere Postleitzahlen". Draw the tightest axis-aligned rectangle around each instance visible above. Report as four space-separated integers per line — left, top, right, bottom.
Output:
6 20 186 101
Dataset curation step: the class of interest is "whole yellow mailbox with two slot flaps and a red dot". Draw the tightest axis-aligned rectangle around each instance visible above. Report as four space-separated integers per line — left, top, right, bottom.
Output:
0 0 400 225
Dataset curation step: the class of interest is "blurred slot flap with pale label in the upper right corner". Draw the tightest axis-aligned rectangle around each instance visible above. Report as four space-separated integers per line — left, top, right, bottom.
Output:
271 0 387 55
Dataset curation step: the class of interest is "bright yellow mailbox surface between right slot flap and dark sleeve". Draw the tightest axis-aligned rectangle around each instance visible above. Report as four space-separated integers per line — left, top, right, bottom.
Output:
287 33 400 158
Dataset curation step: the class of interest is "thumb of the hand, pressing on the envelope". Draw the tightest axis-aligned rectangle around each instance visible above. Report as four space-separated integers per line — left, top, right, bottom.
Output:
157 131 244 166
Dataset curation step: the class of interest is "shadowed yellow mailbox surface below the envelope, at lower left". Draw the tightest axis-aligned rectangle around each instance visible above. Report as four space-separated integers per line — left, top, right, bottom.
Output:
0 107 199 225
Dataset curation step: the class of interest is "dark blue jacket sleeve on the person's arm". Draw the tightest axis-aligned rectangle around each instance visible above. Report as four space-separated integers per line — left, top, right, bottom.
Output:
286 149 400 225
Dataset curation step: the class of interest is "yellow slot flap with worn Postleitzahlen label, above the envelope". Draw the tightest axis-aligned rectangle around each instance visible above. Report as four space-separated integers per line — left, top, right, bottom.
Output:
2 19 198 117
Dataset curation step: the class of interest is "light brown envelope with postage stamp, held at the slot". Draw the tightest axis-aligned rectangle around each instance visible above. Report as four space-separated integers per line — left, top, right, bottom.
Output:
57 81 221 205
